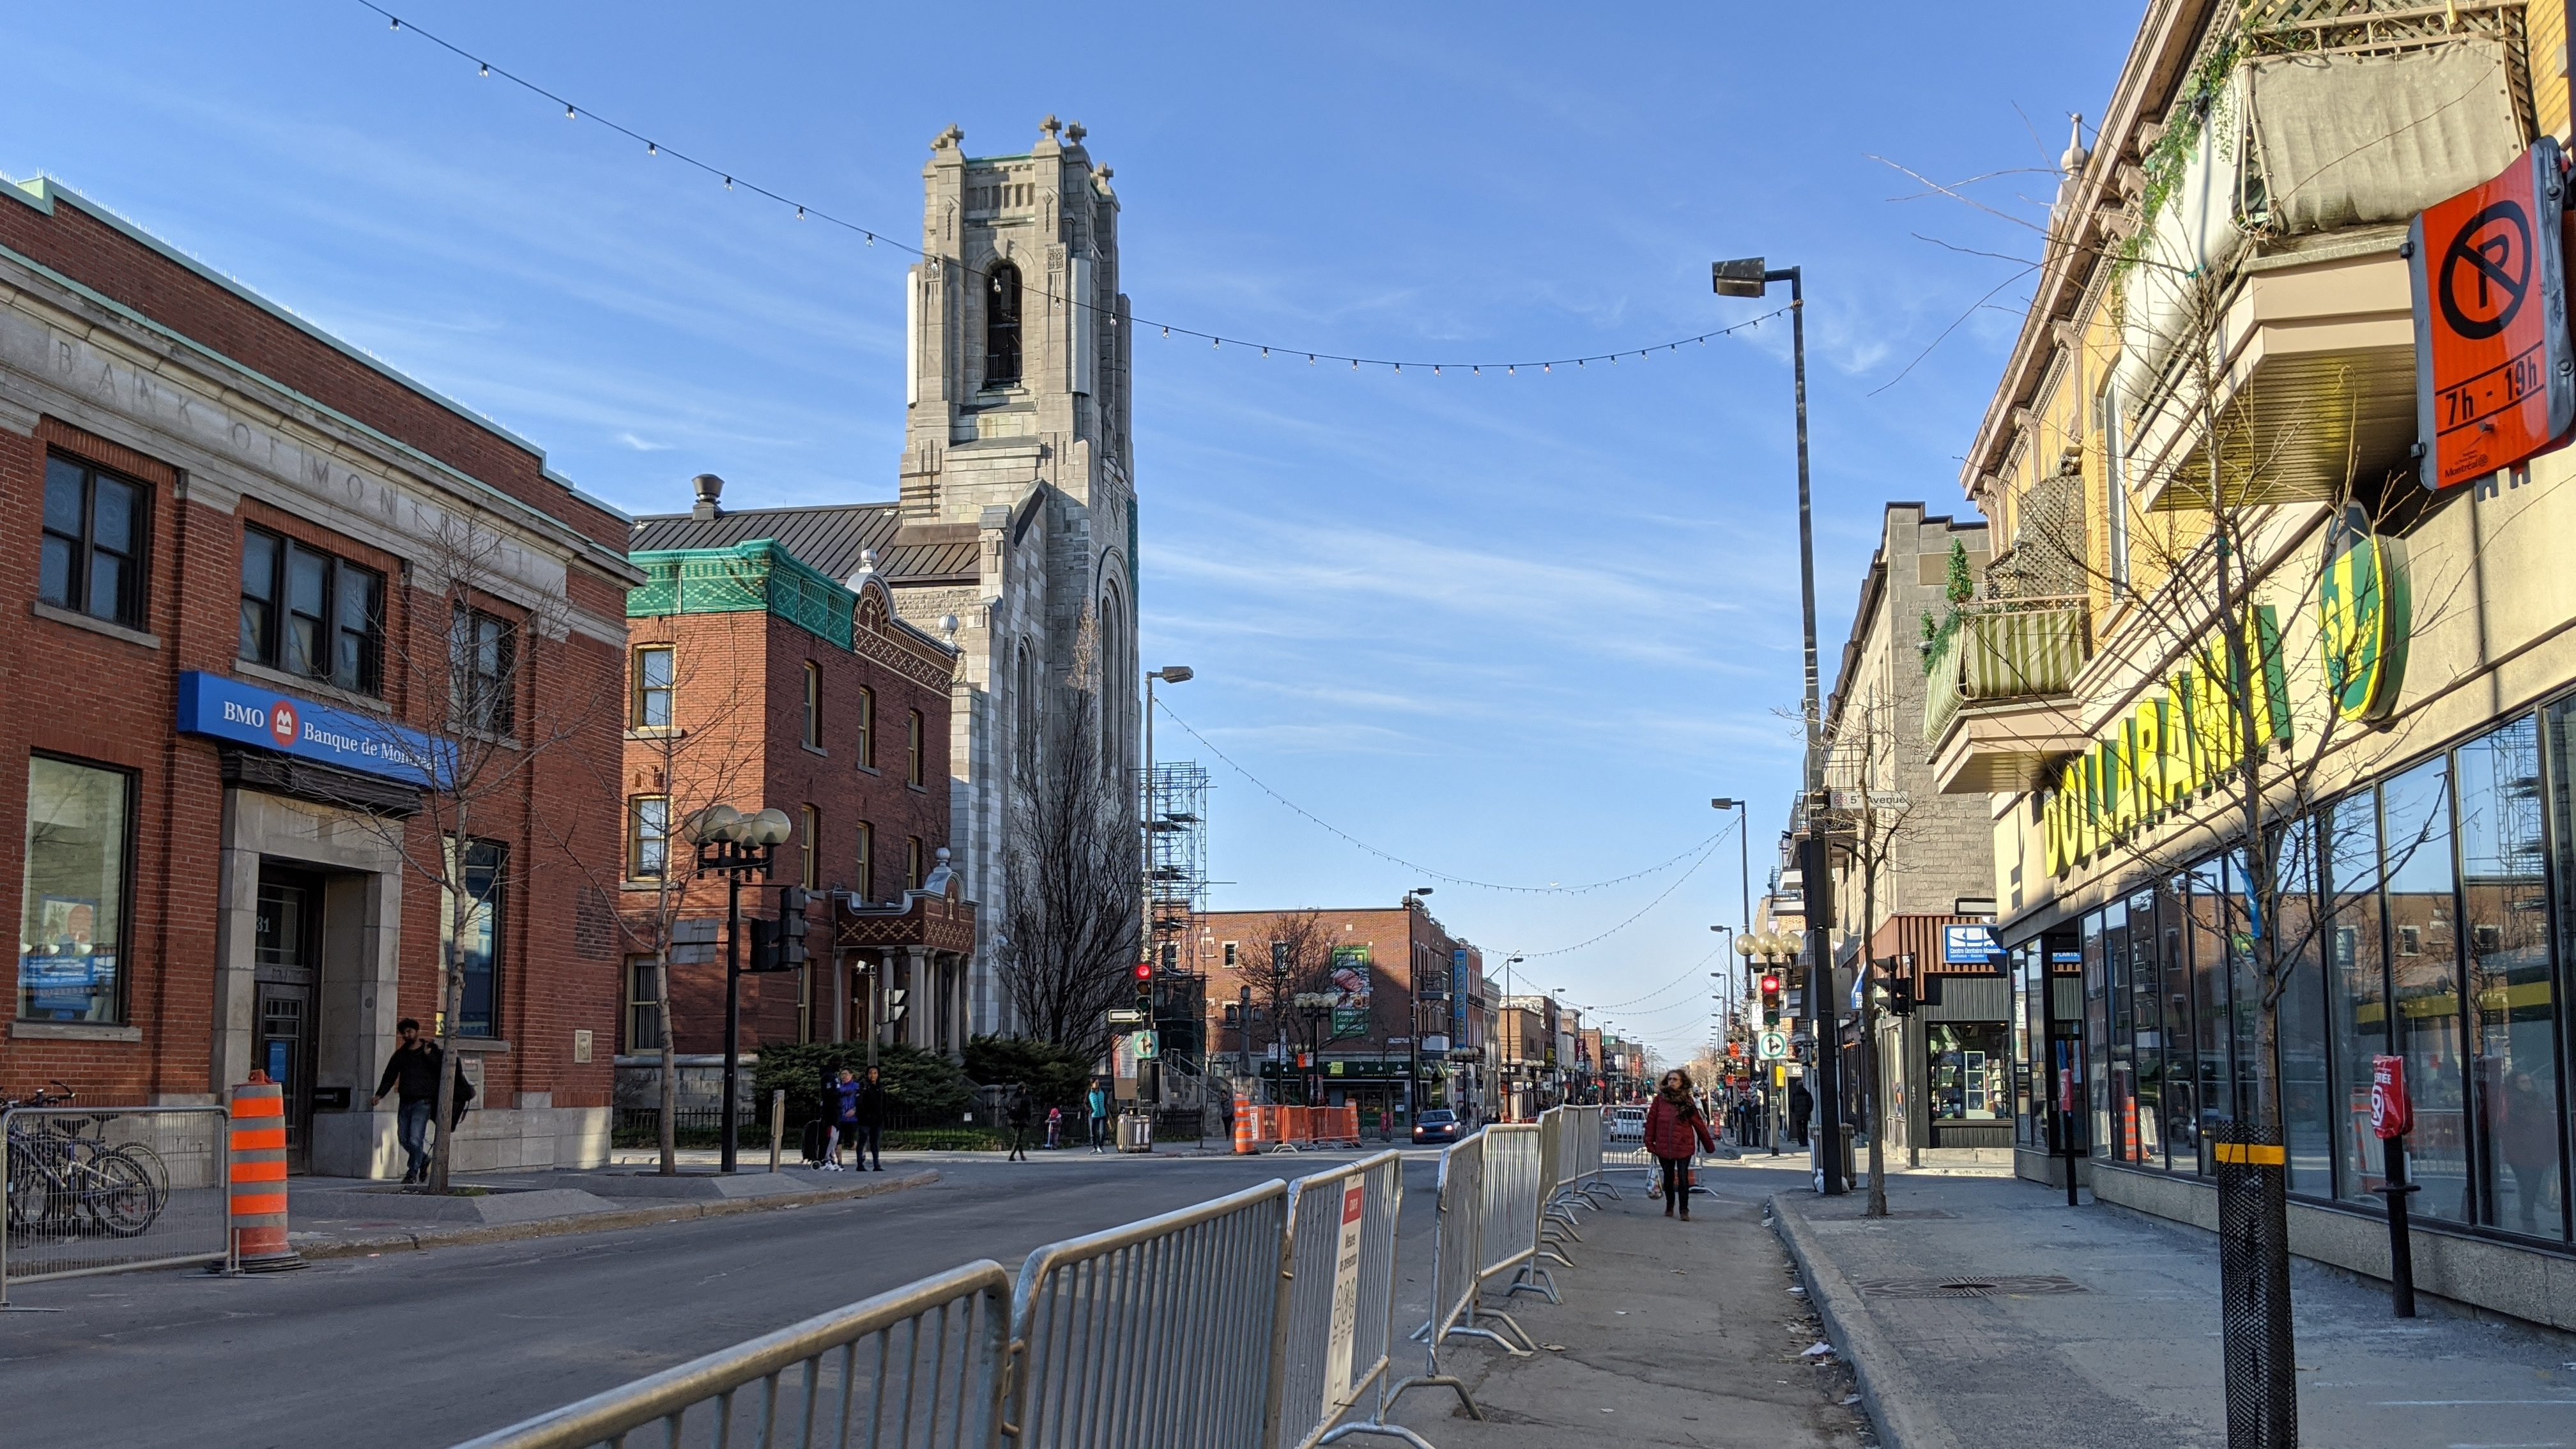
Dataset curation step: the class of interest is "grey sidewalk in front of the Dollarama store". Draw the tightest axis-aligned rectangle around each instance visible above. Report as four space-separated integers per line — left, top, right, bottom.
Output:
1772 1173 2576 1449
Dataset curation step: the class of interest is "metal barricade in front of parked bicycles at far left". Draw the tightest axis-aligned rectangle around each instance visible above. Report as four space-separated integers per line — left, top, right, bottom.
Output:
0 1106 234 1305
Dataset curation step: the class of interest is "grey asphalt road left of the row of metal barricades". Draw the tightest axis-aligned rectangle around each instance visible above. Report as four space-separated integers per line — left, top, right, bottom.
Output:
0 1153 1438 1449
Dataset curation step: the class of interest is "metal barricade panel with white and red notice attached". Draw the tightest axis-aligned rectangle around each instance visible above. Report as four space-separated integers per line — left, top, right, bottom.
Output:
1265 1153 1481 1449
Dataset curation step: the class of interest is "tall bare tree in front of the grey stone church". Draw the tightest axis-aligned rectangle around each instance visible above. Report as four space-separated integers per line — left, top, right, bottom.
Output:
999 617 1144 1060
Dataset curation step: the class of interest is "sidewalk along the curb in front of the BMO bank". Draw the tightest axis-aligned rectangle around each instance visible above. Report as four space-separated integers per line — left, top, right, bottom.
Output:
286 1155 940 1258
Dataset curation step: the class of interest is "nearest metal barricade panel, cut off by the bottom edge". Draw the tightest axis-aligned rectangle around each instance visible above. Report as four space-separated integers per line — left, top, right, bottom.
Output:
459 1261 1010 1449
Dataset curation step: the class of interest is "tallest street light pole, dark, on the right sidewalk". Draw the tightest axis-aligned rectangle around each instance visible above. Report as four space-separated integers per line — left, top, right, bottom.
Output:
1708 258 1844 1197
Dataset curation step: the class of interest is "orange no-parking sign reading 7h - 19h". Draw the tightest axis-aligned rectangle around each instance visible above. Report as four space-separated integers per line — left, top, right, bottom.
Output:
2406 137 2576 490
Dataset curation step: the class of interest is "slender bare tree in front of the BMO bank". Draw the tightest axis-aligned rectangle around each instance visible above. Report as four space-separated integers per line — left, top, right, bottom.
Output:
337 503 616 1193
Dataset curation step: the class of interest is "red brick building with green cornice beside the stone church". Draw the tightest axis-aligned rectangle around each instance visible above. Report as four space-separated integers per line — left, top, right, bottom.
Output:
621 477 974 1055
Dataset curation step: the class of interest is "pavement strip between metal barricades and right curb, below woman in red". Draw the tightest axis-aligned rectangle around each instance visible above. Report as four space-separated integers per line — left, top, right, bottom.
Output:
1393 1168 1867 1449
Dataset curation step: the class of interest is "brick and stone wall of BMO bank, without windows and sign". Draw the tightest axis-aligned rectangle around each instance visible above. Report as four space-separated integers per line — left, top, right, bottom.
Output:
0 183 631 1176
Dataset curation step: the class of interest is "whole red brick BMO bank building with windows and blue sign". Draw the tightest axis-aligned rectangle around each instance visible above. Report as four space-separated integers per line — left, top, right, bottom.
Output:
0 180 636 1176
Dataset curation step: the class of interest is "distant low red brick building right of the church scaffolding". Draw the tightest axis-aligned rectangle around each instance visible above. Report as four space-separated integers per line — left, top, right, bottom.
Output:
1190 897 1483 1127
